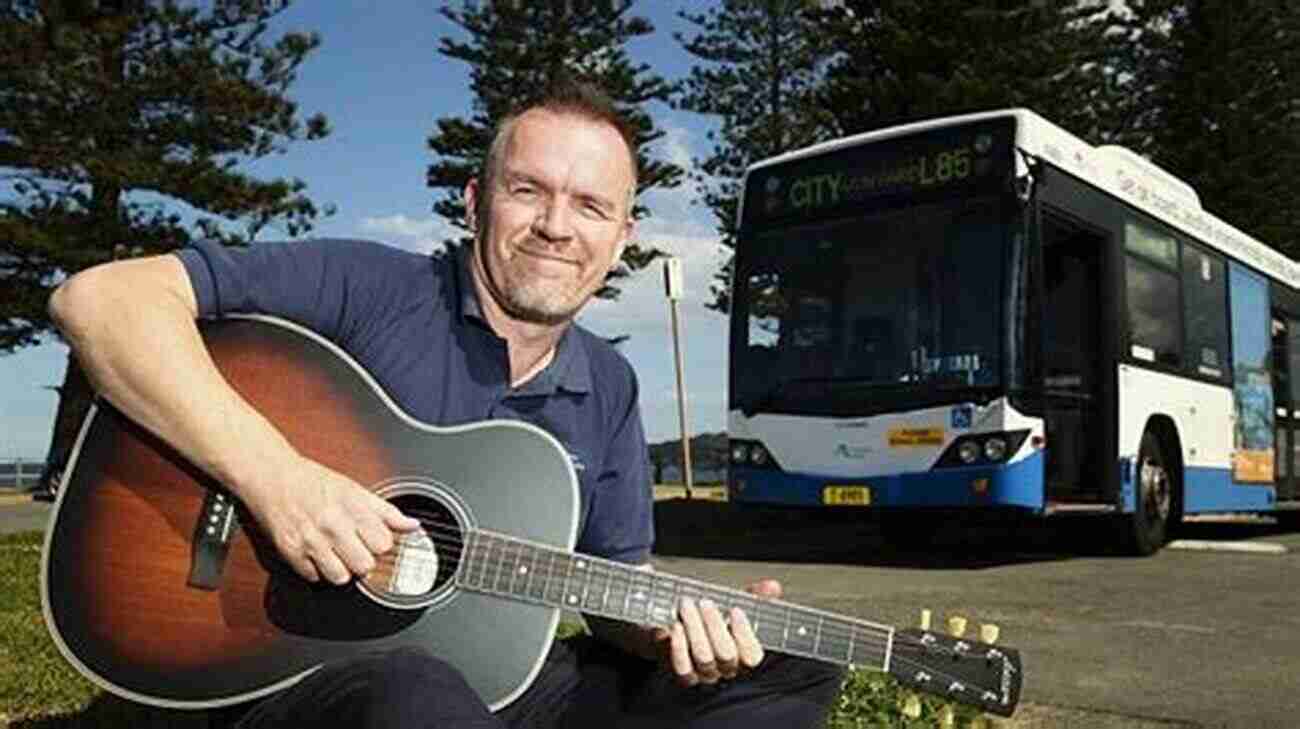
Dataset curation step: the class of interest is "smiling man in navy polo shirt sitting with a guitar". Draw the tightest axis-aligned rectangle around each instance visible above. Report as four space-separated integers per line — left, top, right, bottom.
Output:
51 84 840 729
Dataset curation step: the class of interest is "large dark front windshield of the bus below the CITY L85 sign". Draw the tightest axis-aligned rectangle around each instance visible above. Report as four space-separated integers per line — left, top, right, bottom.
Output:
731 196 1010 416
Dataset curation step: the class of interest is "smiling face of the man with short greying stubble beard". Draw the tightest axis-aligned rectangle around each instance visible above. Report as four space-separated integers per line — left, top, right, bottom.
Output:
465 109 634 324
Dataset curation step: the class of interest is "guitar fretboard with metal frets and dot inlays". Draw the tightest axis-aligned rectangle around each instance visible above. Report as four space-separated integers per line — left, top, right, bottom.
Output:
456 530 894 671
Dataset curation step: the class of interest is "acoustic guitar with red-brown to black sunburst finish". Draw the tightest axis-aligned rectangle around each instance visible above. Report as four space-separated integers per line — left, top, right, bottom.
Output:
42 317 1022 716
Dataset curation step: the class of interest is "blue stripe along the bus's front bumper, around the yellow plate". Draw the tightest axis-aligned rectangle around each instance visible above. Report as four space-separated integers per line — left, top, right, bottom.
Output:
731 452 1044 511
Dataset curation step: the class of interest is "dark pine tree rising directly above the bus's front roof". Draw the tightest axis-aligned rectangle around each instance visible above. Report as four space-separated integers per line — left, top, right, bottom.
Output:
822 0 1115 142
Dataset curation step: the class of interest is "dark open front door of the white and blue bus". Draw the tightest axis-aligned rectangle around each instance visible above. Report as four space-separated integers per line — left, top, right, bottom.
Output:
1040 212 1106 503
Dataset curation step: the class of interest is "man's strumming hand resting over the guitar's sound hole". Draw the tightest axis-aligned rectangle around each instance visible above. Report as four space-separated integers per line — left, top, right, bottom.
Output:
241 457 420 585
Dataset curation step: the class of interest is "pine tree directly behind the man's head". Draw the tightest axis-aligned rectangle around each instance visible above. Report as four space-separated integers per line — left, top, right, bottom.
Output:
428 0 683 298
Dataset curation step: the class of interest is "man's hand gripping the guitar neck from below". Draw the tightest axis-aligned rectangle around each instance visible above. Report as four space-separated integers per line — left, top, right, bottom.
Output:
655 580 781 687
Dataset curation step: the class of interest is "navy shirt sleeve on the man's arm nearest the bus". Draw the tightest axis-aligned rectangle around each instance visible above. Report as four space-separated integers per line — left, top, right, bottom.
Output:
577 365 654 564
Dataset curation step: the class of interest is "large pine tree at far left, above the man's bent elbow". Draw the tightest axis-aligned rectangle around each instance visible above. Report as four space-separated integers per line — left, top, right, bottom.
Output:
0 0 329 483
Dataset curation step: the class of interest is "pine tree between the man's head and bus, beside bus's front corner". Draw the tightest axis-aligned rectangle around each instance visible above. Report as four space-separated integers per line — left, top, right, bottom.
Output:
676 0 832 312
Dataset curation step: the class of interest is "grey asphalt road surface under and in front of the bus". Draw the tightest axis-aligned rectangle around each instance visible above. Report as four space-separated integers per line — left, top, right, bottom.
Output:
10 495 1300 729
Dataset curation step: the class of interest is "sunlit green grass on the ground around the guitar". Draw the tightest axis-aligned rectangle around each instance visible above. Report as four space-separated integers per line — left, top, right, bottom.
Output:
0 533 978 729
